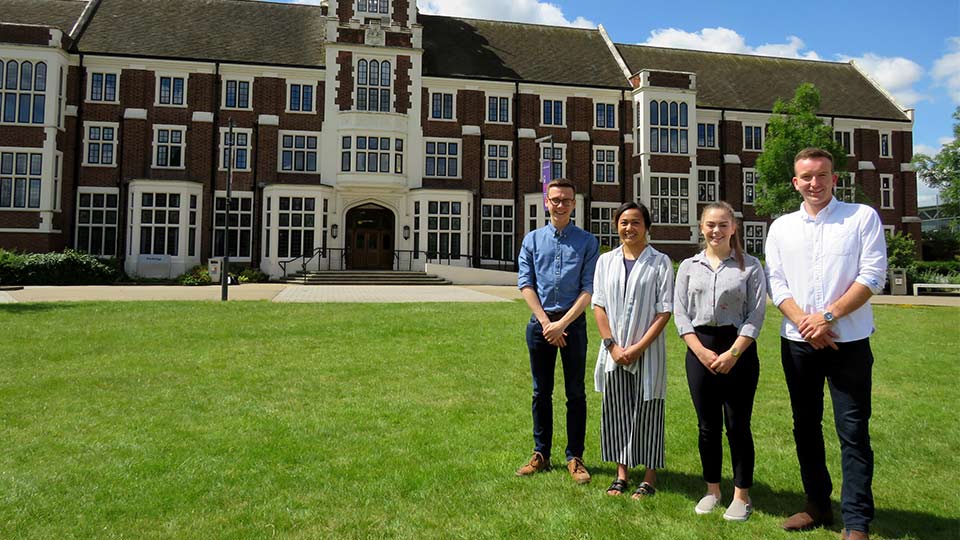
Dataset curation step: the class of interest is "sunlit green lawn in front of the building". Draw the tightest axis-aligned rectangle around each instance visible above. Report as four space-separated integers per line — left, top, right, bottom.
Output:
0 302 960 540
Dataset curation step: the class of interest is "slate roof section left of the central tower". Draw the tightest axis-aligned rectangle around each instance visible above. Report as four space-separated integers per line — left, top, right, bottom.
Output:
79 0 325 66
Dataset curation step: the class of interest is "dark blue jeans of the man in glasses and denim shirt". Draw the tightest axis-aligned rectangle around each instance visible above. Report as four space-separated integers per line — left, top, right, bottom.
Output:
527 314 587 461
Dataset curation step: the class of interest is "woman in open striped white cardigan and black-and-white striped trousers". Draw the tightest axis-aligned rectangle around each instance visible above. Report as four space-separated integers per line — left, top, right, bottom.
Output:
593 202 673 499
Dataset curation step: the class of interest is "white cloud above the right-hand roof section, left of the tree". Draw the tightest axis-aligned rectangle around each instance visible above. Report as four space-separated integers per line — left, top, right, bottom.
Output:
644 27 820 60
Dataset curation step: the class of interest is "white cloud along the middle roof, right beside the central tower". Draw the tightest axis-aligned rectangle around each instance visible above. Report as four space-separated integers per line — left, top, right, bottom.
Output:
417 0 597 28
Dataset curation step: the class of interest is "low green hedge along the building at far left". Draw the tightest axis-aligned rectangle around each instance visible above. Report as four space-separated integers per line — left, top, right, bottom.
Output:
0 249 120 285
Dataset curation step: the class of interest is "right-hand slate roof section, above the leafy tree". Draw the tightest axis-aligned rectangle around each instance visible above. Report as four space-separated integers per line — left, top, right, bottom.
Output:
617 44 908 121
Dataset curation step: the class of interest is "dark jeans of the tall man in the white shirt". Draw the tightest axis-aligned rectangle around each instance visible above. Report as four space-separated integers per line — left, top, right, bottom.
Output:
780 338 874 532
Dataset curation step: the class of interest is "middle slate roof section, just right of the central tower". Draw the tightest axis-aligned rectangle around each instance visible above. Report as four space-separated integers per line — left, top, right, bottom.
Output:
418 14 628 88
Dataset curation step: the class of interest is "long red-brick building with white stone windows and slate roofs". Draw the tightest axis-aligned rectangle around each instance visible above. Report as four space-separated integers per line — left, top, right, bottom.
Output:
0 0 920 276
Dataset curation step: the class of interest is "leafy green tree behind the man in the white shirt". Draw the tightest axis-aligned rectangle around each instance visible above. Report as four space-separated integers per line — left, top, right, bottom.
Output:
754 83 847 216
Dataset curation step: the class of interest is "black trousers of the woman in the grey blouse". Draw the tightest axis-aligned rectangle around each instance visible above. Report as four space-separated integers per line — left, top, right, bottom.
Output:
686 326 760 488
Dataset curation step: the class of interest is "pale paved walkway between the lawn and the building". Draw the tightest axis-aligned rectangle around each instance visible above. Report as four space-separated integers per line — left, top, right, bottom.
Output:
0 283 960 307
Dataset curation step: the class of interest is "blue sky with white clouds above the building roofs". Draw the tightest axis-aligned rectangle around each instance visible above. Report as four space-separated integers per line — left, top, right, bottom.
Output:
275 0 960 205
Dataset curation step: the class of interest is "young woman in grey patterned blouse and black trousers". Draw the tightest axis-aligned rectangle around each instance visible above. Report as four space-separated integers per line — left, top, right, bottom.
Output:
673 202 767 521
